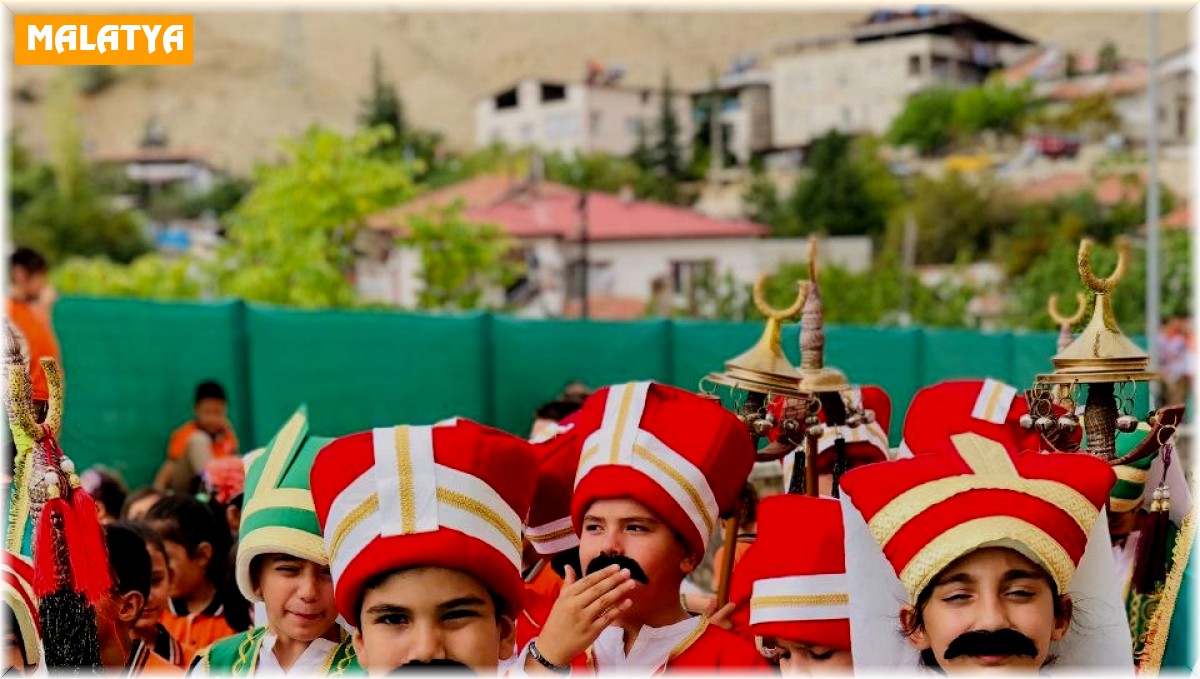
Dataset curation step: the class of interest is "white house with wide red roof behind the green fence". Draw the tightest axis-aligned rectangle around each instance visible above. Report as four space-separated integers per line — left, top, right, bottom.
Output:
356 175 871 318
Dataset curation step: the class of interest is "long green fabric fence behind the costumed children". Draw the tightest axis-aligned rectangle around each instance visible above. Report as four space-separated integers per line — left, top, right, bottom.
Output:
44 298 1147 487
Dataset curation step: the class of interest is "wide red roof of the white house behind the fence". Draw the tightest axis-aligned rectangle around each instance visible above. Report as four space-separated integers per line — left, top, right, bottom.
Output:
367 175 768 241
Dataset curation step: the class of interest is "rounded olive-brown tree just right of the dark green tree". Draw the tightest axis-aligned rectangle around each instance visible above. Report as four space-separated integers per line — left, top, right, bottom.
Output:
887 172 1018 264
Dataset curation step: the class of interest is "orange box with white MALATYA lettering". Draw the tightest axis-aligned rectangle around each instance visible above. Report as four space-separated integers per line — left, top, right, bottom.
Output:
13 14 194 66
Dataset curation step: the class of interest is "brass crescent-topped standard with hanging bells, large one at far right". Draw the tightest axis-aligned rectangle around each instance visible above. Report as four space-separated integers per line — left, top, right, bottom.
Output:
1030 238 1161 462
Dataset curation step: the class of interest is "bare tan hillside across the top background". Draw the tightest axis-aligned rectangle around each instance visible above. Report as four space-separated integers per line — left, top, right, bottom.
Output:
10 6 1188 173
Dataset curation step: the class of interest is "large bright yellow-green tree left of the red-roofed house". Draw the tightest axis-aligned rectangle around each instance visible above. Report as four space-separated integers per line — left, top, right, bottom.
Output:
220 127 414 308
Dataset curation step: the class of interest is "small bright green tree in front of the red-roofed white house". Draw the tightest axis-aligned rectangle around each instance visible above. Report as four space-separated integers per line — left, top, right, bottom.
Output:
401 204 522 311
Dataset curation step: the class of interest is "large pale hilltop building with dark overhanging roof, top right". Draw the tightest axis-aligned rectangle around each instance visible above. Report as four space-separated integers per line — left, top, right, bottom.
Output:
770 6 1032 149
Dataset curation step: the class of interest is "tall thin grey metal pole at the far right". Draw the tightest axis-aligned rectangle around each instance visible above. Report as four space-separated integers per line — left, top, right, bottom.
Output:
1146 6 1162 408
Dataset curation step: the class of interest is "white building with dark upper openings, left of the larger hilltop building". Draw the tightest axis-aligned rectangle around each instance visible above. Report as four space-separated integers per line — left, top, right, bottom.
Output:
475 79 695 156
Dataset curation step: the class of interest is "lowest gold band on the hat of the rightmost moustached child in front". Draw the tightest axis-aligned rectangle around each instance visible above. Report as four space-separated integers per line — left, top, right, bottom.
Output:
899 516 1091 602
